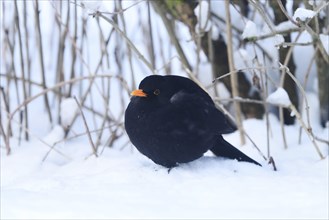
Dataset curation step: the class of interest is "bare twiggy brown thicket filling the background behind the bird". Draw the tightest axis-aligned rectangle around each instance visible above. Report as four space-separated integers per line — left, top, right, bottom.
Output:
0 0 329 165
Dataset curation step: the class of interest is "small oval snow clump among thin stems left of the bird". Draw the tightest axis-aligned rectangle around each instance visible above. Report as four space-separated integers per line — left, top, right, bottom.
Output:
61 98 79 127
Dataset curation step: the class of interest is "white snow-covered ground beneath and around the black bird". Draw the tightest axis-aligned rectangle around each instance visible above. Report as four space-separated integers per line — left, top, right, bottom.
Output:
1 112 328 219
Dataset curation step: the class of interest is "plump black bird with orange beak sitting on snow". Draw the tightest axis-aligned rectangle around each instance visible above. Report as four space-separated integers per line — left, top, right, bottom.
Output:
125 75 261 168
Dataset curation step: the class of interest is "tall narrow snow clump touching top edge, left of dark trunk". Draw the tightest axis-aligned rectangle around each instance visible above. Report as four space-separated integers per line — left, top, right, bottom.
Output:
194 1 212 33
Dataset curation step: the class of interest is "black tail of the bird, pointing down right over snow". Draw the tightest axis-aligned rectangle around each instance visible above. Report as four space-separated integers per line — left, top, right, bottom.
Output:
210 135 262 166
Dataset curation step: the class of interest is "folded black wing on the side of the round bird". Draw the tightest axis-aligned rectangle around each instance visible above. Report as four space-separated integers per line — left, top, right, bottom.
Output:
152 91 231 137
